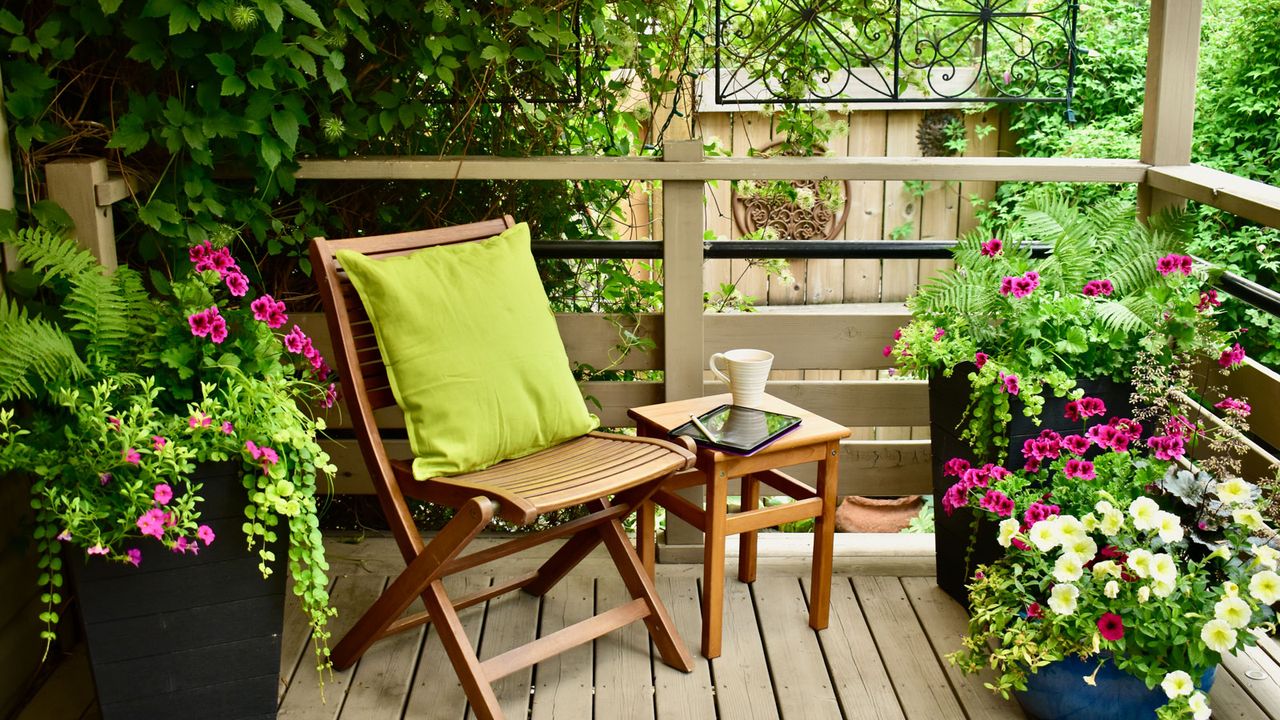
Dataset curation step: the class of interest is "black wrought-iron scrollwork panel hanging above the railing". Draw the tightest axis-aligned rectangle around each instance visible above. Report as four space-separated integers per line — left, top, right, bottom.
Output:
714 0 1078 113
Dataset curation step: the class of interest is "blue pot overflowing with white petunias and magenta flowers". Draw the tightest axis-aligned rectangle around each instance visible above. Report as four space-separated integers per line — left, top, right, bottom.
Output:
945 354 1280 720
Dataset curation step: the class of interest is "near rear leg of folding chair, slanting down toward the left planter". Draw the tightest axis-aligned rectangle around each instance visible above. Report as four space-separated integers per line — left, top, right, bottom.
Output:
330 497 494 670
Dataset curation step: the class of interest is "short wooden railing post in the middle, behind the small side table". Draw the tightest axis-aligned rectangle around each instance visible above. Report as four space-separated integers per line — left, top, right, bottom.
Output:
662 140 704 544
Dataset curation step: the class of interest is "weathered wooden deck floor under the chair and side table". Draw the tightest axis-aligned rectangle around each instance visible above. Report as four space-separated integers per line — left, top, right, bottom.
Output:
19 536 1280 720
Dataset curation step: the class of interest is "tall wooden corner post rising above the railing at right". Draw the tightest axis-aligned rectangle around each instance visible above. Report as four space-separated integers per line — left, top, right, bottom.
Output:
1138 0 1203 219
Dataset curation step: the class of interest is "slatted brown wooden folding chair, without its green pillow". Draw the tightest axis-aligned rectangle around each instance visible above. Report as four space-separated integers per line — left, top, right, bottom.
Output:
311 217 694 719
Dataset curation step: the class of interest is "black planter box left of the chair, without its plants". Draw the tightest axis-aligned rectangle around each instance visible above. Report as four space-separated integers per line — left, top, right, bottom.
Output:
69 462 288 720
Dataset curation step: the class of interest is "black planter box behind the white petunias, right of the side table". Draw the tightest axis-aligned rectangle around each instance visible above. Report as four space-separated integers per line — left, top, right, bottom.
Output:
929 363 1133 607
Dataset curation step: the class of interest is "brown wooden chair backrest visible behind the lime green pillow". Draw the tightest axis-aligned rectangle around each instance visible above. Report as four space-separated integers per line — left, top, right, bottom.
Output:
311 215 515 535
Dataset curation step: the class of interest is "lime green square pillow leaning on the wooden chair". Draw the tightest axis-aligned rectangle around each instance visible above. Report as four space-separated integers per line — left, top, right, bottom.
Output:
337 223 598 480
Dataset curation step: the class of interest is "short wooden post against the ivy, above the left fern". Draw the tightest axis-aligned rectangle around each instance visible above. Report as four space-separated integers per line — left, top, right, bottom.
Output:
45 158 116 272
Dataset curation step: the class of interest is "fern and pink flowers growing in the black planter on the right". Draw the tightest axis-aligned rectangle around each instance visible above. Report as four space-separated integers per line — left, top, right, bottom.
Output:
884 192 1230 461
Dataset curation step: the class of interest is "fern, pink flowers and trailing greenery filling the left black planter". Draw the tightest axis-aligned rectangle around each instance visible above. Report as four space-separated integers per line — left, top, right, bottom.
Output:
0 219 335 666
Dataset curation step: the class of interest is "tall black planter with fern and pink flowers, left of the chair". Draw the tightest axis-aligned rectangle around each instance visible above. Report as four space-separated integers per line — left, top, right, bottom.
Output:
0 220 335 717
